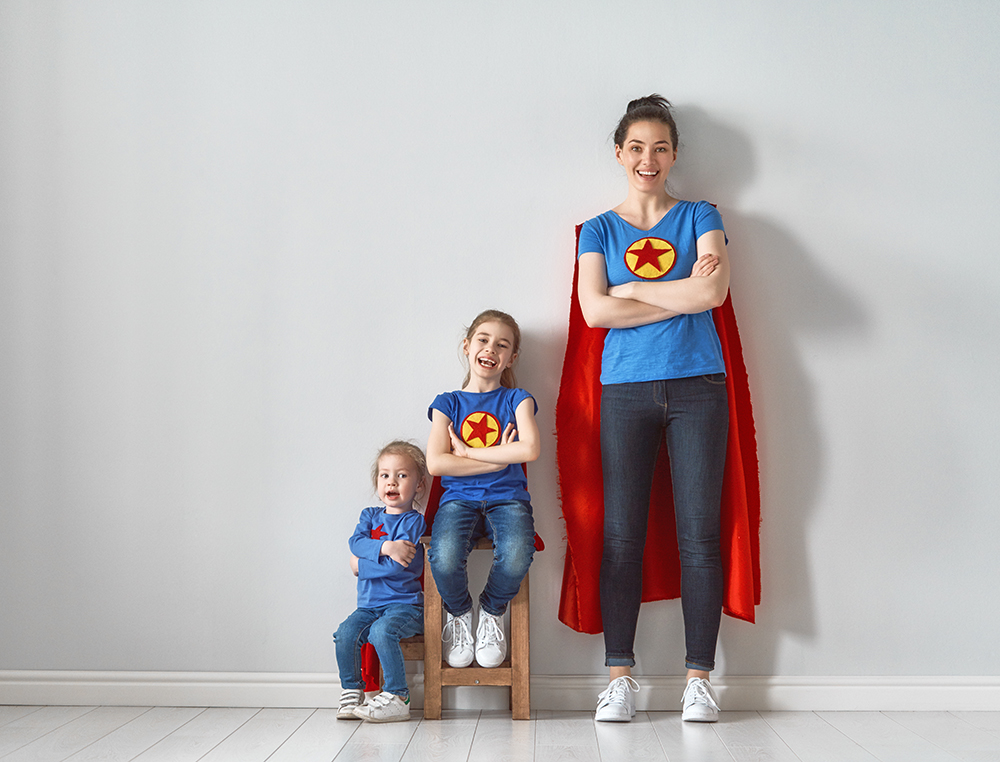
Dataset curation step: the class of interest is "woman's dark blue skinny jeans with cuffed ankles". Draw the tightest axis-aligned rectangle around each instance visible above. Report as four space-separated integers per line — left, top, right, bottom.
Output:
601 373 729 670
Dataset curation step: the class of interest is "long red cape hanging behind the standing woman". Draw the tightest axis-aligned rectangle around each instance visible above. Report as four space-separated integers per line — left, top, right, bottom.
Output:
556 225 760 633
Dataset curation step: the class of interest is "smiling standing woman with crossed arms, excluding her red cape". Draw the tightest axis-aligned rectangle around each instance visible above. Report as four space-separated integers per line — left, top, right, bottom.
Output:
577 95 729 722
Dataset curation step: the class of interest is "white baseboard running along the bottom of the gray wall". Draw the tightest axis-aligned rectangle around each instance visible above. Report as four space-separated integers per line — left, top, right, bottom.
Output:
0 670 1000 711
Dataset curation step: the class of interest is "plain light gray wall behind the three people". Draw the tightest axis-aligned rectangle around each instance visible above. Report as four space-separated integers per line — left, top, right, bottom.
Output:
0 0 1000 676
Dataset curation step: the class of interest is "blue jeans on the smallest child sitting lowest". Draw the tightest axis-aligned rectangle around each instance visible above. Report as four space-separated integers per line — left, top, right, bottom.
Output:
333 603 424 698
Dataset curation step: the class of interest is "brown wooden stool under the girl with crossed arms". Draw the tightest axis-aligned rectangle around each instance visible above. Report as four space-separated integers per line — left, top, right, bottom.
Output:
416 537 531 720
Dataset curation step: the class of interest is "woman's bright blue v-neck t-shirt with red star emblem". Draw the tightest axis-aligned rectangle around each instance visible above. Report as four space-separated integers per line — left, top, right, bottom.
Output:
577 201 726 384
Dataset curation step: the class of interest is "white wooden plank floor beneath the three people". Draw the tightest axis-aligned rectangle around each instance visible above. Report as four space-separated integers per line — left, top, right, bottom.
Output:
0 706 1000 762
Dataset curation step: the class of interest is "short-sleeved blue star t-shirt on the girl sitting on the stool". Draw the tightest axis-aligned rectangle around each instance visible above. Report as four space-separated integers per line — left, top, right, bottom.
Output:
427 386 538 503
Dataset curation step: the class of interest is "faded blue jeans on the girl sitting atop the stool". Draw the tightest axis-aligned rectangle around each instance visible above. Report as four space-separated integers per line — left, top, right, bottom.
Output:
427 500 535 616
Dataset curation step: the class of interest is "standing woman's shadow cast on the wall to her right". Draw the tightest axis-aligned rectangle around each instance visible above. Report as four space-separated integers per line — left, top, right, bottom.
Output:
670 107 870 674
